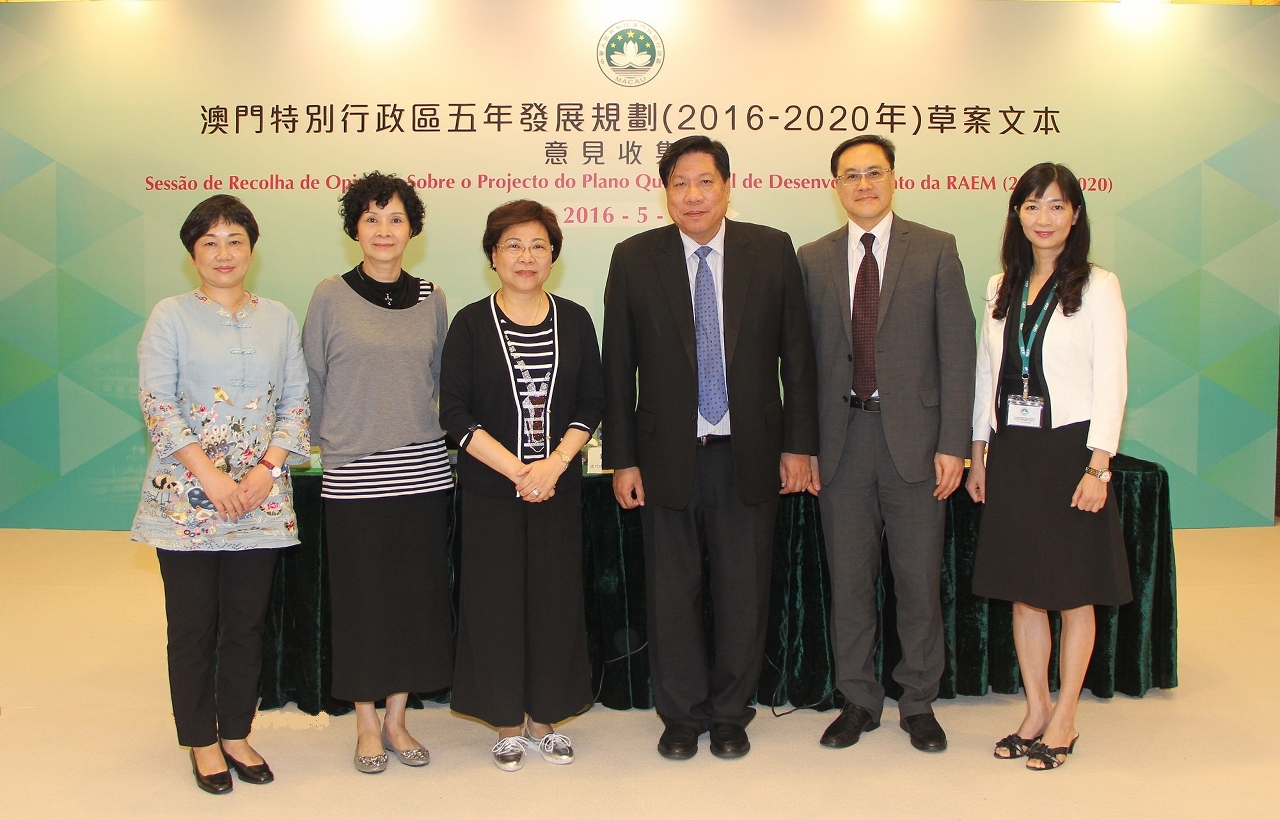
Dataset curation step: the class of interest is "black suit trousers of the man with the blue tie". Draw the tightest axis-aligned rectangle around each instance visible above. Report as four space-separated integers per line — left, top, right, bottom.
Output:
640 440 778 732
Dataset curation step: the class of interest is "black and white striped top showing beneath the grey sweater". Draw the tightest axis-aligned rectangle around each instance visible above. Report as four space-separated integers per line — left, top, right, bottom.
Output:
320 279 453 499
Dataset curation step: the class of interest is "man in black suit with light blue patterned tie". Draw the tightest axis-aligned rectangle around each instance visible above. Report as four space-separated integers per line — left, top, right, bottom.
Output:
603 136 818 760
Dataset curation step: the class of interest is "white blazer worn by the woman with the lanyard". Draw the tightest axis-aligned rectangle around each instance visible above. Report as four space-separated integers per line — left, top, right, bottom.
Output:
973 265 1129 455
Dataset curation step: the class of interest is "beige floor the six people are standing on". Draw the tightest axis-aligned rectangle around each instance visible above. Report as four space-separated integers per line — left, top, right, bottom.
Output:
0 527 1280 820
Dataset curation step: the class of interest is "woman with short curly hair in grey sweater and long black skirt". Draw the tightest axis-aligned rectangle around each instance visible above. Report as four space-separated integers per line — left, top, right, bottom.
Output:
302 171 453 774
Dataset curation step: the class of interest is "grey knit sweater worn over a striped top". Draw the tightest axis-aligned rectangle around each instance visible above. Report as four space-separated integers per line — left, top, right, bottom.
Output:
302 276 449 467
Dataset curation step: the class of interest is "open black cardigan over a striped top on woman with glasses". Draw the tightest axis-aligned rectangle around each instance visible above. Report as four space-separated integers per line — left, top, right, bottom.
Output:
440 293 604 498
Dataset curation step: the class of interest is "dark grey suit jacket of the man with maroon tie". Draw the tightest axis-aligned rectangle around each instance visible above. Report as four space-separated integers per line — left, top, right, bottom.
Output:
799 214 977 484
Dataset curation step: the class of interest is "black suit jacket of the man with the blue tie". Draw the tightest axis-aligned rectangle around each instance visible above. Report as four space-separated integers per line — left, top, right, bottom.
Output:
602 220 818 509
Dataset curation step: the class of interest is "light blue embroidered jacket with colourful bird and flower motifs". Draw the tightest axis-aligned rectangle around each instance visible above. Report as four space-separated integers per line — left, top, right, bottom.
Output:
132 290 311 550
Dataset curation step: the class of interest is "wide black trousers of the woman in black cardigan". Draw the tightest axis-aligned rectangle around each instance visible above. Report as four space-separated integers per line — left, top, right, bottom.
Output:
452 485 591 727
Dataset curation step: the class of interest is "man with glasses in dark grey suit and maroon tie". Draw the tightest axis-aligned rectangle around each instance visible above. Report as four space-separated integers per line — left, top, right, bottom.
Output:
799 134 977 751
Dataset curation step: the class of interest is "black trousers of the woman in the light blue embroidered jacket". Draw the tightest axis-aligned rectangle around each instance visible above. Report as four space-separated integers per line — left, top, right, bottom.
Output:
156 549 279 746
